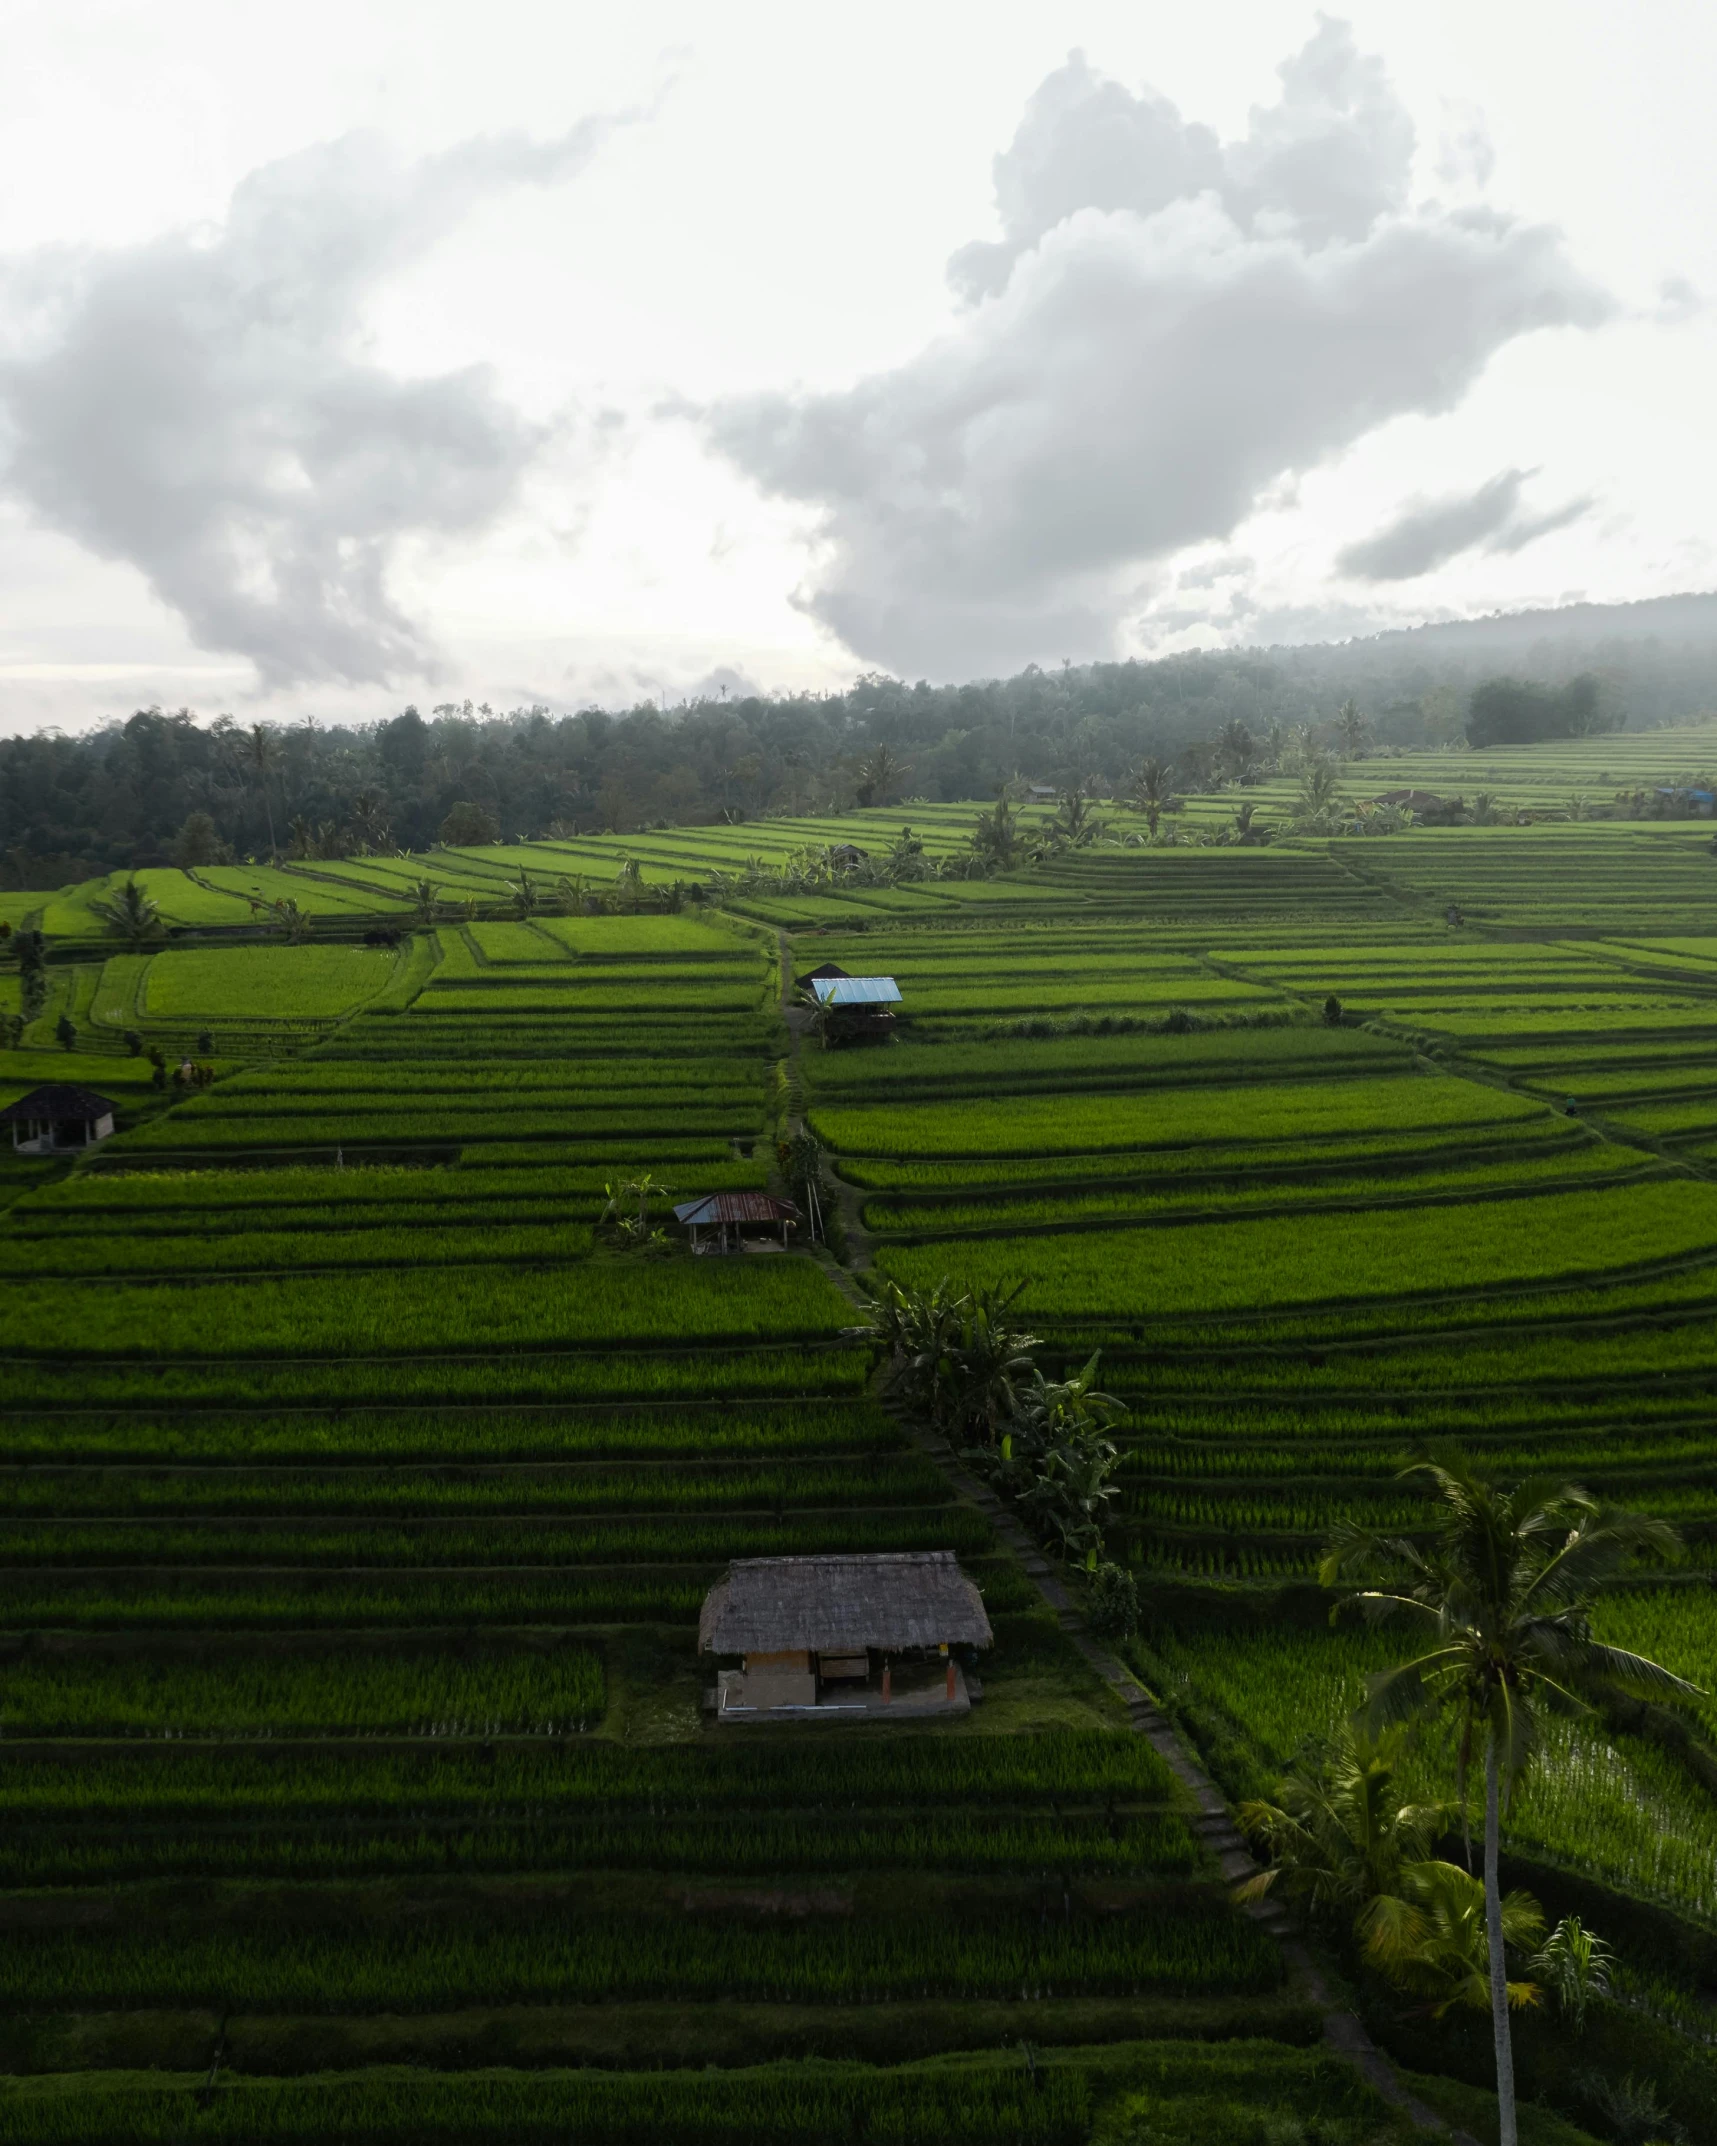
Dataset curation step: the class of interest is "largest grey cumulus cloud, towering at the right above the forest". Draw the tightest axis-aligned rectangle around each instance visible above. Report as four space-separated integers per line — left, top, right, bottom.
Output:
704 21 1610 676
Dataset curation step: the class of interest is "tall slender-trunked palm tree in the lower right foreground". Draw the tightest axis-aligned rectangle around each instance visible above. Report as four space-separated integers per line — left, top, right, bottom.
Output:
1318 1455 1700 2146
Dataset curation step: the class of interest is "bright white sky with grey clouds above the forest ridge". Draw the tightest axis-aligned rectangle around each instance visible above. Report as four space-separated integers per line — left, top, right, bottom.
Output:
0 0 1717 734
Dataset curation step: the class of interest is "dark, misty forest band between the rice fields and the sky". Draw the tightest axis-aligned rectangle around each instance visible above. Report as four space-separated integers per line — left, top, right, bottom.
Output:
0 597 1717 888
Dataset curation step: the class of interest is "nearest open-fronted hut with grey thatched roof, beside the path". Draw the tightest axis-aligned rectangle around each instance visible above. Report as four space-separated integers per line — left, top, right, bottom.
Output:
698 1549 994 1719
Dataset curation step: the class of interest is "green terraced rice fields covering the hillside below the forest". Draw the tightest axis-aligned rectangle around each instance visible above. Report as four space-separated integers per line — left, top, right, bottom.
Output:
0 730 1717 2146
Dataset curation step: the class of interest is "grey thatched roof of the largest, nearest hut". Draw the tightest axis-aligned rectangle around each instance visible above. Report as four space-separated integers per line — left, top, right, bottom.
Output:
698 1549 994 1655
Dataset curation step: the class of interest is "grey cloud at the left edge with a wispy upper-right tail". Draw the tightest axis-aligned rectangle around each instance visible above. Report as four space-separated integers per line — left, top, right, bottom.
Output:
0 118 616 687
